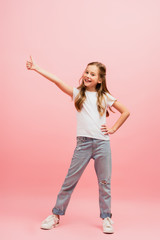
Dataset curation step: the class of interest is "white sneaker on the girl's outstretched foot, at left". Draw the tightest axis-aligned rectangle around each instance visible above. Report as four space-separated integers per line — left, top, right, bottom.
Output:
41 214 59 229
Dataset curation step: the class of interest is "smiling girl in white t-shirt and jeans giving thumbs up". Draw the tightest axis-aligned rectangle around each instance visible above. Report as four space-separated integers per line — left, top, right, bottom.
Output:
26 56 130 233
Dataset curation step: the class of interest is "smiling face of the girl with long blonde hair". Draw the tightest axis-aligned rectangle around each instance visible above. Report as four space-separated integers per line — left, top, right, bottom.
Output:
82 65 101 91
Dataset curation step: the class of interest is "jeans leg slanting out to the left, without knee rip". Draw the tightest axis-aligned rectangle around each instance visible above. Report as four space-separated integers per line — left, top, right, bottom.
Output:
52 137 92 215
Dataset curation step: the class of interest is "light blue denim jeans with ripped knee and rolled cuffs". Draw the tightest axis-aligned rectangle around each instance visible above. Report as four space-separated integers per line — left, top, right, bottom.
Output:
52 136 112 218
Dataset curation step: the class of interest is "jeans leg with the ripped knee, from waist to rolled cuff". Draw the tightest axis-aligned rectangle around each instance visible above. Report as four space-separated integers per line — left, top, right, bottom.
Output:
93 139 112 219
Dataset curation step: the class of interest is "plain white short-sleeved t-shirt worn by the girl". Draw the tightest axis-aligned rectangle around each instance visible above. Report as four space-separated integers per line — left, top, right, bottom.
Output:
73 87 117 140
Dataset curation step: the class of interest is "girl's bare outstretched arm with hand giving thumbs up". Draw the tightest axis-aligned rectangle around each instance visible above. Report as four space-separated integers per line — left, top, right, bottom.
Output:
26 56 73 97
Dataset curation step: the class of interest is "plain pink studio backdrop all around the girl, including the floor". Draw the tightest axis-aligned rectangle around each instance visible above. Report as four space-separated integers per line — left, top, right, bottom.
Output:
0 0 160 239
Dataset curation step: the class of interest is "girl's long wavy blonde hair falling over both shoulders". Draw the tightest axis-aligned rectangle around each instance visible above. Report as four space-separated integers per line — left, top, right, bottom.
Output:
74 62 115 117
